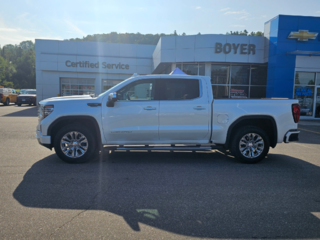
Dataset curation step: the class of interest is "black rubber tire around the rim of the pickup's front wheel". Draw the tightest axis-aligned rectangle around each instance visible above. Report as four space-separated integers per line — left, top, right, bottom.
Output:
54 124 98 163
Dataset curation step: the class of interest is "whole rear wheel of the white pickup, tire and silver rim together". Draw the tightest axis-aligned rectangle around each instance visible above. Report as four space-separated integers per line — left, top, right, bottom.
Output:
231 126 270 163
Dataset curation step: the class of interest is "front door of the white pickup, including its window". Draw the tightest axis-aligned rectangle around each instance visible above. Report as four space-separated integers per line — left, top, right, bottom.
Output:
102 78 159 144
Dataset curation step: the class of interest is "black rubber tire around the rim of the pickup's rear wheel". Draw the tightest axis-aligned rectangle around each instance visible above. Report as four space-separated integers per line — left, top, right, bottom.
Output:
230 126 270 163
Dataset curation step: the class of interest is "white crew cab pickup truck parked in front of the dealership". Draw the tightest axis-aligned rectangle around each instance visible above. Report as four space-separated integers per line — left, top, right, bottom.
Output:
36 75 300 163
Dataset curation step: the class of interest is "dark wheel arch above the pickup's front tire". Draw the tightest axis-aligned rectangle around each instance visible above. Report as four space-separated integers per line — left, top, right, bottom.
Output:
47 115 102 150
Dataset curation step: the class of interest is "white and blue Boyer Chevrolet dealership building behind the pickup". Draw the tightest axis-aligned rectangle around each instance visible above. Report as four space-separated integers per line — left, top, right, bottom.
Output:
35 15 320 119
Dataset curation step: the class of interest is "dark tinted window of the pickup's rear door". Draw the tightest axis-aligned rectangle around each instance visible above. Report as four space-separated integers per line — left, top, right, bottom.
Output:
160 79 200 100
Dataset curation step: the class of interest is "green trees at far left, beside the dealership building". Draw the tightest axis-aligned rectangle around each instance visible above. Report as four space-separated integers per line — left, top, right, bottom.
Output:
0 41 36 88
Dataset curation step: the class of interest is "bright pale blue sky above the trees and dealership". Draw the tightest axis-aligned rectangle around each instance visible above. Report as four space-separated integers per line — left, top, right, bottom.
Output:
0 0 320 46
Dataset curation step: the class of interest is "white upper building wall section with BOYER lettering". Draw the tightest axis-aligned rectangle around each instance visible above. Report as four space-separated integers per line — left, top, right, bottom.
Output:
153 34 265 71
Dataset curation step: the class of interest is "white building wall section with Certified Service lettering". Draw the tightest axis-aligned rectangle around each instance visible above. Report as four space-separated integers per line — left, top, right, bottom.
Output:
36 39 155 102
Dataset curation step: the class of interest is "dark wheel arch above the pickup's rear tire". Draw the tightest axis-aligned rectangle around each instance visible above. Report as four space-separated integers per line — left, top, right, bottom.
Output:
225 115 278 149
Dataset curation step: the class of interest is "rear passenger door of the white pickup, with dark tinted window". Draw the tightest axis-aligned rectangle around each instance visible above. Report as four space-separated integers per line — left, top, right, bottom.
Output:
159 78 211 143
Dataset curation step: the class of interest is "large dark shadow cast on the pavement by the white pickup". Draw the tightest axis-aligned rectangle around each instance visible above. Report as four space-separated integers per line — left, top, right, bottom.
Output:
13 151 320 239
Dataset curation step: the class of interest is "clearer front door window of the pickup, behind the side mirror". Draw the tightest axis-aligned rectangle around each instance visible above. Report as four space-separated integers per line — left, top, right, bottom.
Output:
117 79 156 101
